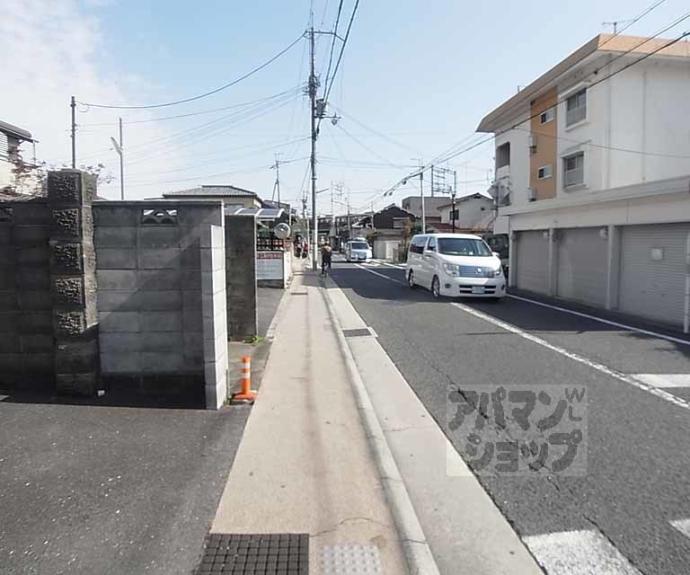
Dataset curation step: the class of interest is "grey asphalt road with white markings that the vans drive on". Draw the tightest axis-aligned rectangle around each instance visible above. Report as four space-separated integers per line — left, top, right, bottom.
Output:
332 263 690 575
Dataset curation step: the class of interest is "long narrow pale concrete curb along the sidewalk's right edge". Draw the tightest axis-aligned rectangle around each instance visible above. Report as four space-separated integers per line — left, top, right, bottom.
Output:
321 280 440 575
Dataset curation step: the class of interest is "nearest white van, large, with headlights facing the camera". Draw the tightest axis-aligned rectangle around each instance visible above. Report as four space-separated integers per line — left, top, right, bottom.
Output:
405 234 506 298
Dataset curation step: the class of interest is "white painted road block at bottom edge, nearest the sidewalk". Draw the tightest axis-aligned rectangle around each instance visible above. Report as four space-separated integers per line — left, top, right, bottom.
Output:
523 530 641 575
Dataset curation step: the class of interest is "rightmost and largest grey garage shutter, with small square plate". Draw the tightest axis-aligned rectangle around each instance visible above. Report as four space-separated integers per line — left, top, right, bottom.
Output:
618 223 690 325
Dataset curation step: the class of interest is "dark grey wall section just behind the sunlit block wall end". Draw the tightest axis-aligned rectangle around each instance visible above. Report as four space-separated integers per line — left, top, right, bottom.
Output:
225 216 258 339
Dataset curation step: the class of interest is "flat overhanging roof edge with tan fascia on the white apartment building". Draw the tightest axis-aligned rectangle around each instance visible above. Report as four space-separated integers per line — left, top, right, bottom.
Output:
477 34 690 132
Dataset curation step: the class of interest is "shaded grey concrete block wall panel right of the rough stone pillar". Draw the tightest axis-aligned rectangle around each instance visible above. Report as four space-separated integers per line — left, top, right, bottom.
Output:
93 201 223 398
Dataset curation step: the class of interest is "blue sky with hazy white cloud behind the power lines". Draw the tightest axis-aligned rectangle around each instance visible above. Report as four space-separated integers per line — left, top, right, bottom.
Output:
0 0 687 212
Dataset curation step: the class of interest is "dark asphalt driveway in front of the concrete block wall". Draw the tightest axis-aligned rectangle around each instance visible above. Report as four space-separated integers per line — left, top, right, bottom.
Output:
0 394 249 575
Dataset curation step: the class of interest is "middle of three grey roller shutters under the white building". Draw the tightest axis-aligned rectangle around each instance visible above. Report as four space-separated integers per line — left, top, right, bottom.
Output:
556 228 608 306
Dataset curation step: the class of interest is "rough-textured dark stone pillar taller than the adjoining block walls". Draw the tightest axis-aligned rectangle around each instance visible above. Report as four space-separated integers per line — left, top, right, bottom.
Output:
48 170 98 395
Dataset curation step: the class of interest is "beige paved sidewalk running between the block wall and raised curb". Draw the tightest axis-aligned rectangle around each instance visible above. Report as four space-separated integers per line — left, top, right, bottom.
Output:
211 272 407 575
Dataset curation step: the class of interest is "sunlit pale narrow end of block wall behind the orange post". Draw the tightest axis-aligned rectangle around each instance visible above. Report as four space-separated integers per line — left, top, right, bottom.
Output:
201 226 228 409
